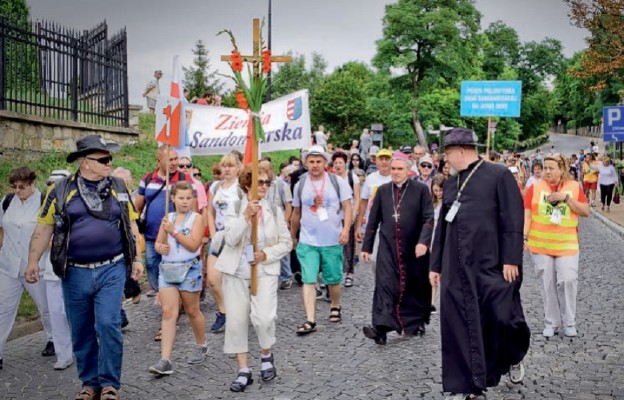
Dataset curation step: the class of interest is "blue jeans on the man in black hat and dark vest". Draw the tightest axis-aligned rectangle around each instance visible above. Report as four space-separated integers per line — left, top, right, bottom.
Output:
63 259 126 391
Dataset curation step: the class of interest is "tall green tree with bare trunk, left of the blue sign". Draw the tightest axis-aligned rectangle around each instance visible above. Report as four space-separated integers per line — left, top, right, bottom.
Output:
373 0 481 145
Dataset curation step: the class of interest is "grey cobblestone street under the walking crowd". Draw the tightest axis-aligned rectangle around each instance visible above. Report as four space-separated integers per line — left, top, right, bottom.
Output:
0 217 624 400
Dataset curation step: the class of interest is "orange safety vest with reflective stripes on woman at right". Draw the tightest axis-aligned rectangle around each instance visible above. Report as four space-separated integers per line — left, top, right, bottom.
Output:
527 180 580 257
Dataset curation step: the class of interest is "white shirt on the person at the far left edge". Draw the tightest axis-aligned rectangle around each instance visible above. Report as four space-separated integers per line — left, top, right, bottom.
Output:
0 189 44 279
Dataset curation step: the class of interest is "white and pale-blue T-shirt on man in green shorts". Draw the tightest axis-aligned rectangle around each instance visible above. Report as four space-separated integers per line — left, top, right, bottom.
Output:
293 173 353 247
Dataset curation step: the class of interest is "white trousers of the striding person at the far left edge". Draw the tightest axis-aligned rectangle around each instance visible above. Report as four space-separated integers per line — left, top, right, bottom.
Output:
0 273 52 358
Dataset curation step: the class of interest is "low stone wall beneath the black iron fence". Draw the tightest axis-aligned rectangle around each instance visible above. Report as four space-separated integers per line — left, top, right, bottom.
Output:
0 106 141 154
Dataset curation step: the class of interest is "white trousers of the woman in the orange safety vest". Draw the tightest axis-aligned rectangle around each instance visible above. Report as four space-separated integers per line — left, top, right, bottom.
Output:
531 253 579 329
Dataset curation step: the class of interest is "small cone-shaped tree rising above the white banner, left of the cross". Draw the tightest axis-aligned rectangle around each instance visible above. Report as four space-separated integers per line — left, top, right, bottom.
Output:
183 40 223 97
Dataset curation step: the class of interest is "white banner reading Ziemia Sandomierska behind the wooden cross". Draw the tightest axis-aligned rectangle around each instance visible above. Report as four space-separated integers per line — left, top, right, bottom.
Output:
186 90 311 155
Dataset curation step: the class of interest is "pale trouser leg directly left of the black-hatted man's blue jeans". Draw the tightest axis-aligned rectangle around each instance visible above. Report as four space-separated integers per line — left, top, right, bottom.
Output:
46 281 74 361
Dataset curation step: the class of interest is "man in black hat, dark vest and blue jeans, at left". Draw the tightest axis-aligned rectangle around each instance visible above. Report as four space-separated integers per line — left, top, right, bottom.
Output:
24 135 143 400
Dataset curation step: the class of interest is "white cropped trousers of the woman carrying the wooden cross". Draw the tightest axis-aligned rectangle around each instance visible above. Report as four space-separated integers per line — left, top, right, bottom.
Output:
222 274 279 354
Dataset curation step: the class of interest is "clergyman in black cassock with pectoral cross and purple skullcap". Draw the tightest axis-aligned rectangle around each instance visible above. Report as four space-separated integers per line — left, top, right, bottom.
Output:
361 152 433 344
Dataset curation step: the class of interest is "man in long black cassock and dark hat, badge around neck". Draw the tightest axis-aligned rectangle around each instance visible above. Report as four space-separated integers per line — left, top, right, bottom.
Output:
429 128 531 400
